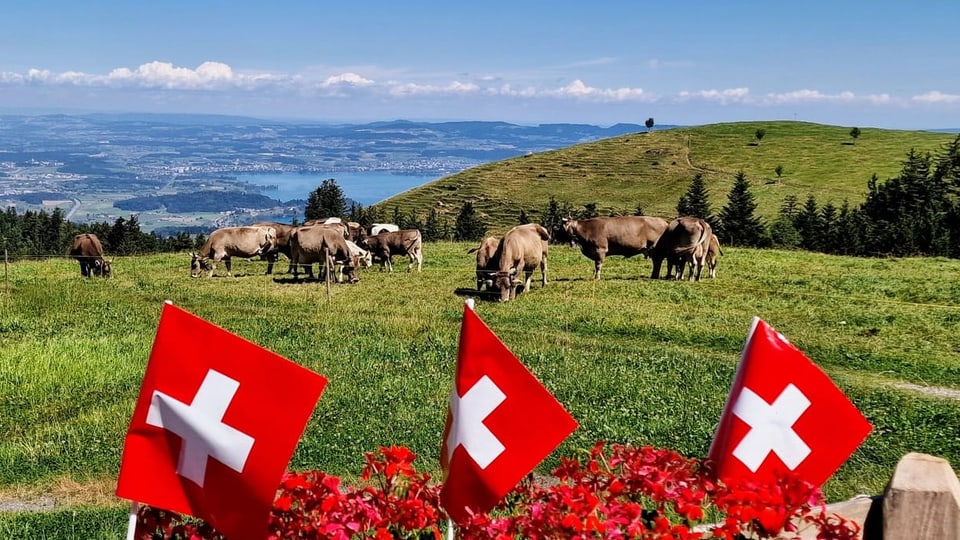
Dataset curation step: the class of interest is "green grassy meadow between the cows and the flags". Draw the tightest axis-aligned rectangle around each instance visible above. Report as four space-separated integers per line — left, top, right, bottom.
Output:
0 242 960 538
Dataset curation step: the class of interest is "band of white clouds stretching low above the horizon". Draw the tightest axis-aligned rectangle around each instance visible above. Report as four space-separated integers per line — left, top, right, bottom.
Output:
0 61 960 128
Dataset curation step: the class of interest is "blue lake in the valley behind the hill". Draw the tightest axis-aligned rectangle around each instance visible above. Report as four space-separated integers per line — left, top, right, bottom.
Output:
237 171 441 206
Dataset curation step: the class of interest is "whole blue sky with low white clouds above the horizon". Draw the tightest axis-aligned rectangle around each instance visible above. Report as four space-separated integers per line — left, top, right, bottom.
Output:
0 0 960 129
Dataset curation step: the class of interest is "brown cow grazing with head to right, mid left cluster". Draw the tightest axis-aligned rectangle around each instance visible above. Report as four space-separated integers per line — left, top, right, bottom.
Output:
290 226 360 283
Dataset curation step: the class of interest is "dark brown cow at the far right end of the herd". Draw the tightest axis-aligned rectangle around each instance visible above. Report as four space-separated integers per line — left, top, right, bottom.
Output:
650 216 713 281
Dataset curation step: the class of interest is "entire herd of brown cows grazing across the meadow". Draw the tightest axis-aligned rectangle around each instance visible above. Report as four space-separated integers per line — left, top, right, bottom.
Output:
70 216 722 301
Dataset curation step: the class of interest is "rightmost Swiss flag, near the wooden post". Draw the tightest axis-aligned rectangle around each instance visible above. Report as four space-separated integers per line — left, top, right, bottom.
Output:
710 318 873 486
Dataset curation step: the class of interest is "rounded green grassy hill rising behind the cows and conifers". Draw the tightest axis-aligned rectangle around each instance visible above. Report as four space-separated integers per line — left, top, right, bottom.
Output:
377 122 956 233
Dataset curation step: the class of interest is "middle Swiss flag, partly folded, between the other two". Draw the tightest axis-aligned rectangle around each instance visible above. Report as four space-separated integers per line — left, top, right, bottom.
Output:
440 303 577 522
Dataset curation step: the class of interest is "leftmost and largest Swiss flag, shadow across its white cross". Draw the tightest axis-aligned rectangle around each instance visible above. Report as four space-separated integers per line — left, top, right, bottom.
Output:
117 303 327 540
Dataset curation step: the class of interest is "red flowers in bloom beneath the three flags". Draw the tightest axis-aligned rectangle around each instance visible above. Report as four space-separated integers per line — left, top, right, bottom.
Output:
137 442 860 540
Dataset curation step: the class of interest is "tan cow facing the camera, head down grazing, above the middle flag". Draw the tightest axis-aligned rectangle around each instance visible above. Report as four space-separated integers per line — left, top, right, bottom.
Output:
494 223 550 302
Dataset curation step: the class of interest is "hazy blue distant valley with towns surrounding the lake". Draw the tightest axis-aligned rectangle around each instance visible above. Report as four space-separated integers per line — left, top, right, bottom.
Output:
0 114 660 232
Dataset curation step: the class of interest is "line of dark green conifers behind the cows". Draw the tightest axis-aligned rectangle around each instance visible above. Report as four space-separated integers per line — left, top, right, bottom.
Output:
0 136 960 258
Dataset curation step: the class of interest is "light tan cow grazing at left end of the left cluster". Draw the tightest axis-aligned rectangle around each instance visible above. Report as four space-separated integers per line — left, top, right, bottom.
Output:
190 227 277 277
